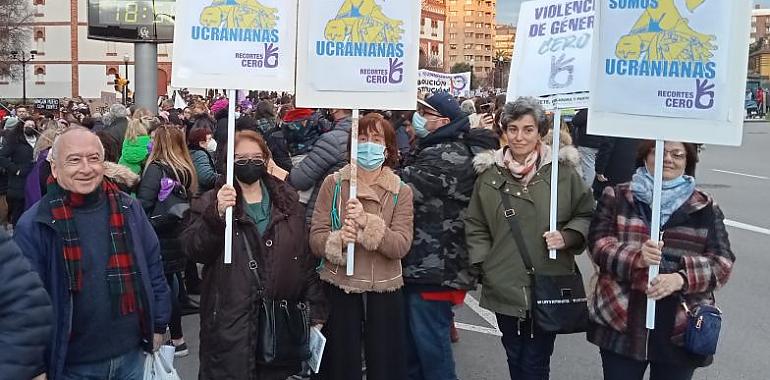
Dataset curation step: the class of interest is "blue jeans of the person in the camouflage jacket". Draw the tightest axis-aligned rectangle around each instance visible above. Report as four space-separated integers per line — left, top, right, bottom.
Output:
404 289 457 380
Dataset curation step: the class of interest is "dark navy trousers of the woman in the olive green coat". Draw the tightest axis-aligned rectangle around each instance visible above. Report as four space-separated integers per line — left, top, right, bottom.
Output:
496 314 556 380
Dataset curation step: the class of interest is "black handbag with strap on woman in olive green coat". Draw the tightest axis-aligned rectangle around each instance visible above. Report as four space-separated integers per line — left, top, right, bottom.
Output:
500 189 588 334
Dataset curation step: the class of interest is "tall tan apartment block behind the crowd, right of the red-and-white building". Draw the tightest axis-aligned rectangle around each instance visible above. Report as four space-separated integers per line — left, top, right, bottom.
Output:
445 0 498 85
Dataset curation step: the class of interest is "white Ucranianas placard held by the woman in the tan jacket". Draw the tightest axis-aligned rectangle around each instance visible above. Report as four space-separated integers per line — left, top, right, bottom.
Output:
296 0 420 110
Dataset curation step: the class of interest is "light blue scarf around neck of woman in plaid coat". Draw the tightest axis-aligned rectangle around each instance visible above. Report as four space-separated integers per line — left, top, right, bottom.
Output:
631 167 695 226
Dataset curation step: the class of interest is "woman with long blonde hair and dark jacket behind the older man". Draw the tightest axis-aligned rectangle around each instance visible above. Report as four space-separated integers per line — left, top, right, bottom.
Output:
136 125 198 356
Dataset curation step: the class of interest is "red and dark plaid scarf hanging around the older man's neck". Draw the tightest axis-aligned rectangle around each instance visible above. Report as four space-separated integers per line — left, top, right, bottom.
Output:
48 177 143 315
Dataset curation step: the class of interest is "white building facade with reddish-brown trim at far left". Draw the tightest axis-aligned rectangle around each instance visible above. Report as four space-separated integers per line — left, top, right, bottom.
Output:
0 0 172 99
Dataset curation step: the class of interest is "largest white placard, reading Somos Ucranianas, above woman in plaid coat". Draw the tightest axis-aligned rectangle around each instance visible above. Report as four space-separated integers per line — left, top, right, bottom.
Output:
588 0 752 145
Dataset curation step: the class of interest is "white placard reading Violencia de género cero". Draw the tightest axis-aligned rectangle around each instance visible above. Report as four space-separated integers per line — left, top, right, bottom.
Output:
507 0 595 109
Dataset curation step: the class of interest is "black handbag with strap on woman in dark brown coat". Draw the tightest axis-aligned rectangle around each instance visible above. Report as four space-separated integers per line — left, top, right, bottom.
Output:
243 235 310 366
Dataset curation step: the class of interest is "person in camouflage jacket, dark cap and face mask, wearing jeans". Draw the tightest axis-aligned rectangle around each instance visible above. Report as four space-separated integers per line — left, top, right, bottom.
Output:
399 93 499 380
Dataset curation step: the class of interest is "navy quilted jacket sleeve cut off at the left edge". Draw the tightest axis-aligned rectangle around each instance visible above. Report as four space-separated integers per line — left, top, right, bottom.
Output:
0 231 53 379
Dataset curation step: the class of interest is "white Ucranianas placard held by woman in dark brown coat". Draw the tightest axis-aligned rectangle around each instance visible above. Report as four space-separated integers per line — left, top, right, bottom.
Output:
171 0 297 91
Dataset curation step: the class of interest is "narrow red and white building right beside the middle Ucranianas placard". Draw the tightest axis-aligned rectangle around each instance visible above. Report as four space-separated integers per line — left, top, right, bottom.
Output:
420 0 447 72
